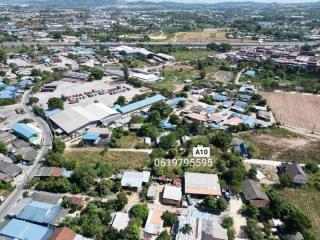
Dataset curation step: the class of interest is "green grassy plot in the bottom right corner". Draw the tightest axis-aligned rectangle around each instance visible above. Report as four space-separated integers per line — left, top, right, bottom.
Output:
279 188 320 239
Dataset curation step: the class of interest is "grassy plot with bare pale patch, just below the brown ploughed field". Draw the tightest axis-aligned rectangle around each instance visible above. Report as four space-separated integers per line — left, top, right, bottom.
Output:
240 128 320 163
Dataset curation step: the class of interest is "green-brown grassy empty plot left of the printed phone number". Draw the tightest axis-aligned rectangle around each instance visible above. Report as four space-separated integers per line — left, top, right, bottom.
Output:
65 148 150 169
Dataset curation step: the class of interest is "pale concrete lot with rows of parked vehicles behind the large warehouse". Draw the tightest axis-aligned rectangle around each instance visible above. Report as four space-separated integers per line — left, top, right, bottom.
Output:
35 77 141 108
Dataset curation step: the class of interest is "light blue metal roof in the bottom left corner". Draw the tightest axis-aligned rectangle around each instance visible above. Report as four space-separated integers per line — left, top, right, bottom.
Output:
0 219 52 240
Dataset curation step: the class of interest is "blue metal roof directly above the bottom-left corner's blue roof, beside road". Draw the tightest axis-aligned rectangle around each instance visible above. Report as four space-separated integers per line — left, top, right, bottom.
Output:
17 201 61 224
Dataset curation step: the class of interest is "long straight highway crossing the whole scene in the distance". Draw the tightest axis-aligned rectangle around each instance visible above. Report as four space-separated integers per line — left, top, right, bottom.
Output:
1 40 320 48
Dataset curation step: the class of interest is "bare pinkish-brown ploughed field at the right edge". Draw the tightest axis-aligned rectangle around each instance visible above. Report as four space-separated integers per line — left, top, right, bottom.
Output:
264 92 320 132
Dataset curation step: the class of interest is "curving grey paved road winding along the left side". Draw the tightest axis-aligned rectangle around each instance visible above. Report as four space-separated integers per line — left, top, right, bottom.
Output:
0 91 53 220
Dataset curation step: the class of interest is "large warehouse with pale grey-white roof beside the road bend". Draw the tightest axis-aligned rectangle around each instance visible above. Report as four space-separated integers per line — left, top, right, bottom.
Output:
49 103 121 135
